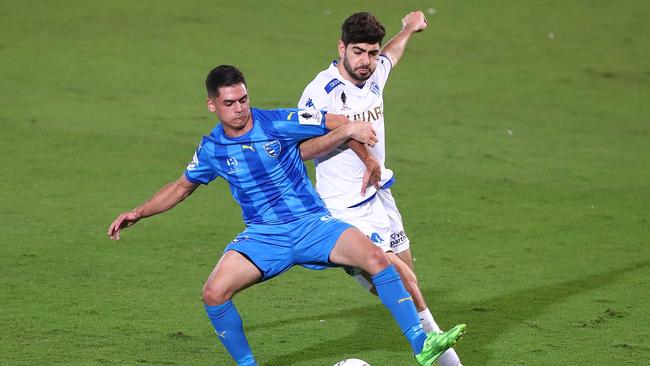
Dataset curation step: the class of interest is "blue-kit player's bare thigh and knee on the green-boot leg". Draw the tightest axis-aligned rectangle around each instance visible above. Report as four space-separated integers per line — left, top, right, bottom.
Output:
330 228 389 275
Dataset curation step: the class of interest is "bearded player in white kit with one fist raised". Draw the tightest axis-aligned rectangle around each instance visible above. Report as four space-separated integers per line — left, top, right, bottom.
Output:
298 11 461 366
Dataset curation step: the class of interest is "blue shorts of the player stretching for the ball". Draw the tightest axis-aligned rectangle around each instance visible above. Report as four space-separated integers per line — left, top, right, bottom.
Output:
224 211 352 281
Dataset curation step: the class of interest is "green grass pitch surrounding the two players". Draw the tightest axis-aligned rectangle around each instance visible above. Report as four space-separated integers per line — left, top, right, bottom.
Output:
0 0 650 366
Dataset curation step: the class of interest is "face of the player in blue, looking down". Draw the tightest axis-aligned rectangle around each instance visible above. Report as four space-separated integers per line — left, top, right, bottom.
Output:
207 84 253 136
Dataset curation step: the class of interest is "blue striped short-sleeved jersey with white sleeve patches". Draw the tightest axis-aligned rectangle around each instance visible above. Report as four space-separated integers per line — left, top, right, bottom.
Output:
185 108 328 225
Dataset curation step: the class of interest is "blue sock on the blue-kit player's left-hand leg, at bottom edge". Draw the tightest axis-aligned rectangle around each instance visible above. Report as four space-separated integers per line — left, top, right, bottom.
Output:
204 300 257 366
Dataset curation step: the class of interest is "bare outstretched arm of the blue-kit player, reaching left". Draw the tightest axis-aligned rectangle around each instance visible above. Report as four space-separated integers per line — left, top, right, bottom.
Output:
108 175 199 240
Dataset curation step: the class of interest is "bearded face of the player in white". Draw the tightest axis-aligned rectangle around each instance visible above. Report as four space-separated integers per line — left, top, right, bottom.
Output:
339 41 381 83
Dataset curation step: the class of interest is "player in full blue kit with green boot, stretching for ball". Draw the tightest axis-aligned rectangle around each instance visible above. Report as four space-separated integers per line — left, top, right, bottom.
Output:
108 65 465 366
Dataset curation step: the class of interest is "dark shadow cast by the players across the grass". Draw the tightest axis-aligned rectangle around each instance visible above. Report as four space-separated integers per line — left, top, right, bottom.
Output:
251 261 650 366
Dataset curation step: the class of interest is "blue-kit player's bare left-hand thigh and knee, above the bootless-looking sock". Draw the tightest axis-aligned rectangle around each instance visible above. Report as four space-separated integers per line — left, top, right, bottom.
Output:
203 250 262 302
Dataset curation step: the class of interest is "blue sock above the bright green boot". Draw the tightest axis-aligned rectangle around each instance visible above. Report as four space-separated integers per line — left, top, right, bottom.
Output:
372 265 427 354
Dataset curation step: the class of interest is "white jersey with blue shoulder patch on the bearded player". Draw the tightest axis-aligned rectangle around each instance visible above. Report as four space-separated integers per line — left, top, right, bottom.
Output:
298 55 393 208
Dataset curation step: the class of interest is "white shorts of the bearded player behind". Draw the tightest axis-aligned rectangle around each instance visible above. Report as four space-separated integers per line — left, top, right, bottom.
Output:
329 189 410 253
